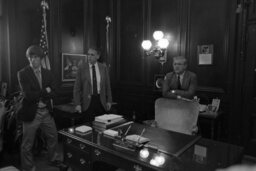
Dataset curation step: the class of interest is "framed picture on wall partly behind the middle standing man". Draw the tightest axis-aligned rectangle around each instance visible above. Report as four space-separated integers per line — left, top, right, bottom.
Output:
61 53 87 81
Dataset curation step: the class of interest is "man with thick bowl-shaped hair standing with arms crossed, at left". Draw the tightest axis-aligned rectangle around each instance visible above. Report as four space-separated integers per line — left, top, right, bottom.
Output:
18 45 60 171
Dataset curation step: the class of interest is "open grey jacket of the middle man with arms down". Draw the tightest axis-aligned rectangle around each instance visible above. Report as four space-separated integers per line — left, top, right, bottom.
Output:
74 62 112 111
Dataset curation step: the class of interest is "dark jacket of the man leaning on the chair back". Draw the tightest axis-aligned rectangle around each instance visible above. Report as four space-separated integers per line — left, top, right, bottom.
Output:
162 71 197 99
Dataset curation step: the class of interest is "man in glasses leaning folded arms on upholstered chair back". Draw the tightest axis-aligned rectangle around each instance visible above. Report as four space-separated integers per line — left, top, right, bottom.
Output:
162 56 197 99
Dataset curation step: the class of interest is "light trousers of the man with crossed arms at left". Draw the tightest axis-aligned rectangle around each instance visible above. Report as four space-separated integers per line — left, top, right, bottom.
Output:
21 108 60 171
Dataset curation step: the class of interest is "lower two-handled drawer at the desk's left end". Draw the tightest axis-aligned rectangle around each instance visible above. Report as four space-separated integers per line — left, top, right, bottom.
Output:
64 144 91 170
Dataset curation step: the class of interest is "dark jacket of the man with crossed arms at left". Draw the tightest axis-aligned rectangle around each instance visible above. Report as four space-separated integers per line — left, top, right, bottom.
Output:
18 66 56 122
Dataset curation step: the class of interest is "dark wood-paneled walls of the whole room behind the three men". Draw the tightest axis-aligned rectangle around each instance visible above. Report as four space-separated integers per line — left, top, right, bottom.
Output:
2 0 246 142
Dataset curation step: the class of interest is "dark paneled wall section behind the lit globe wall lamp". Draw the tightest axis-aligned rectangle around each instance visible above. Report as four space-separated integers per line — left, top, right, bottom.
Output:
110 0 236 123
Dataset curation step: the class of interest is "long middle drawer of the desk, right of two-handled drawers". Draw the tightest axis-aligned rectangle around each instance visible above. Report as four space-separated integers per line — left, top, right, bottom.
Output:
92 148 154 171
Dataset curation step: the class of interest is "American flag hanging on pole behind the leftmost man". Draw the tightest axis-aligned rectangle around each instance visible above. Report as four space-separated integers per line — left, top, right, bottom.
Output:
39 0 51 70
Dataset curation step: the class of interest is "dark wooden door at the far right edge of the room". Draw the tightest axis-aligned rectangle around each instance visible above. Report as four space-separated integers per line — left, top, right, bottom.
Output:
241 21 256 156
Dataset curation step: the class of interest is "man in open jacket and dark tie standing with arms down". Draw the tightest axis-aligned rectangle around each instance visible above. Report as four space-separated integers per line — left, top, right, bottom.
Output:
74 47 112 122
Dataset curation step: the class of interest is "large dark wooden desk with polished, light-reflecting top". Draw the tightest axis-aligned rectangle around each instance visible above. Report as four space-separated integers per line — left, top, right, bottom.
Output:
59 123 243 171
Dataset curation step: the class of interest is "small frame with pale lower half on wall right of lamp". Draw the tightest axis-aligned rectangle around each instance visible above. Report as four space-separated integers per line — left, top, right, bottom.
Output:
197 45 213 65
